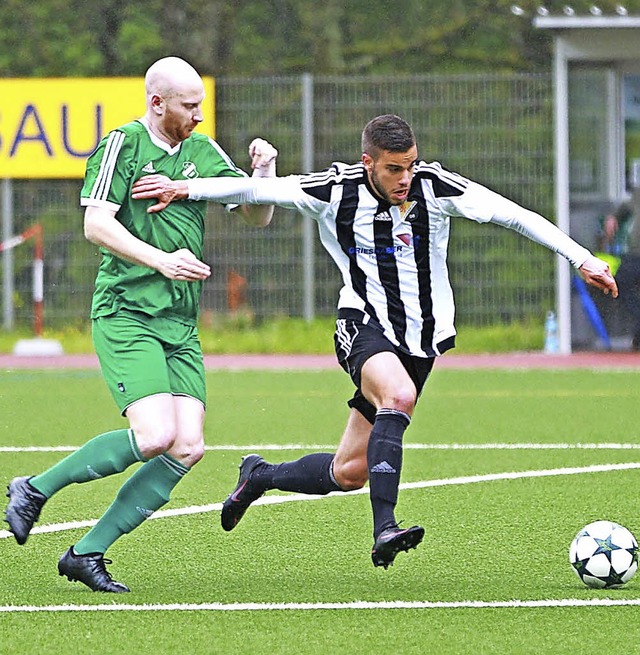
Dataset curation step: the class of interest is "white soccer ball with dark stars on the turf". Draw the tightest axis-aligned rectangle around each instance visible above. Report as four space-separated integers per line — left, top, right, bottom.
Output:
569 521 638 589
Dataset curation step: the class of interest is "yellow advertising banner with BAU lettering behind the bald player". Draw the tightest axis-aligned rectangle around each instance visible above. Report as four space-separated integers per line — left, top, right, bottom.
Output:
0 77 215 179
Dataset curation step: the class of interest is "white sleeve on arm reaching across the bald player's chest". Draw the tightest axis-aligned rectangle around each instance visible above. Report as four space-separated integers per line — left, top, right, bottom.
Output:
188 175 326 214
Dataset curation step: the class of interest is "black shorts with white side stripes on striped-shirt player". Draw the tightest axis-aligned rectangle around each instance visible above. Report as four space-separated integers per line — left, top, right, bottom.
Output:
333 311 435 425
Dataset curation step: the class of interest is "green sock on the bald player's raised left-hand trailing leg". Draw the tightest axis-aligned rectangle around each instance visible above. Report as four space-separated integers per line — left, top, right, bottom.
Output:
29 430 145 498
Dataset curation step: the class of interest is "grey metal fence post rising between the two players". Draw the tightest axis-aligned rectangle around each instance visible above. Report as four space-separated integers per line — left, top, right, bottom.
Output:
301 73 315 321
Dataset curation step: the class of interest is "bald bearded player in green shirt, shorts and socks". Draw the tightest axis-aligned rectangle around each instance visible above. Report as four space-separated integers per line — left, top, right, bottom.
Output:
5 57 277 593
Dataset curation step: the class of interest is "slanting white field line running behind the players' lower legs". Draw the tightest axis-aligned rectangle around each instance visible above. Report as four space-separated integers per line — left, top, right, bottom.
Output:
0 462 640 539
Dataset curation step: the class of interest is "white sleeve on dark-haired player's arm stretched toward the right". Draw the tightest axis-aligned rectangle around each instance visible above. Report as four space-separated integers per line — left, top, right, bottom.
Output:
449 182 591 268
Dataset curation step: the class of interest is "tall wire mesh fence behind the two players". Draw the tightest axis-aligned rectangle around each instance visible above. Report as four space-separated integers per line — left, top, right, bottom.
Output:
0 75 554 328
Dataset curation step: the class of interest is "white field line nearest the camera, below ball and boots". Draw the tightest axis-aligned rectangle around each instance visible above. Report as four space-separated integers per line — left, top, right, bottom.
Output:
0 598 640 613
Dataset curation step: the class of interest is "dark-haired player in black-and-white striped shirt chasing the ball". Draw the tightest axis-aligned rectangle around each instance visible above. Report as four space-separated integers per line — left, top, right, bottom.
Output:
133 115 617 569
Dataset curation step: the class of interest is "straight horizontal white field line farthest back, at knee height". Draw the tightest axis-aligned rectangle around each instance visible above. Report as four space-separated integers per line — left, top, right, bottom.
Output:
0 442 640 453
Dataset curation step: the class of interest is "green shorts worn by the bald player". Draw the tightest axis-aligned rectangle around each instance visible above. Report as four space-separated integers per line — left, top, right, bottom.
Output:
92 310 206 414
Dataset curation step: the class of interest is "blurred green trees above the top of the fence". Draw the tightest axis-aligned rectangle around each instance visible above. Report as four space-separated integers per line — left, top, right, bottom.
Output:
6 0 640 77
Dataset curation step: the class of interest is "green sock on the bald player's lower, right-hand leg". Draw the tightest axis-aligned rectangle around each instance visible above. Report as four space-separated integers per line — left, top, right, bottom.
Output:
73 453 190 555
